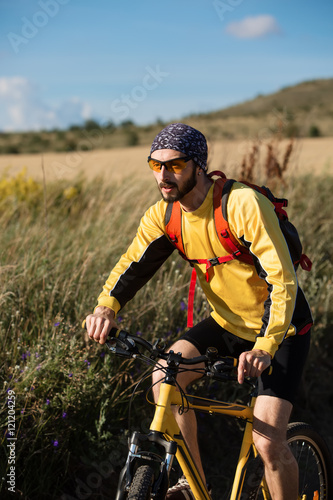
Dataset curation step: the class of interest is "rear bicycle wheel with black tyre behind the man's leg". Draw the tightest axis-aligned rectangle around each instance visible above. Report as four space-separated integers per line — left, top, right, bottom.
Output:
253 422 333 500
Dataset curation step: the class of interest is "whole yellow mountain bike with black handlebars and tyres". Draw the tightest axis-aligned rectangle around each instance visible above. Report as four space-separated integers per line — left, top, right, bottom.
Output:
107 329 333 500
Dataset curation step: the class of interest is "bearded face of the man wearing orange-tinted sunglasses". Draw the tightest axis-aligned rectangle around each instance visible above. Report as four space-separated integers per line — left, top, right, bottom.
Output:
151 149 198 202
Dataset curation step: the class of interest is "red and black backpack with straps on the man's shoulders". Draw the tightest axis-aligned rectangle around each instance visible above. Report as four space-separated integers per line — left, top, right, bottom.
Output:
165 170 312 327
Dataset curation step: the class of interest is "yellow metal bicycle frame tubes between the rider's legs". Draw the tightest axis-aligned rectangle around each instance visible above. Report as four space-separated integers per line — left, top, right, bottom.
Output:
150 383 266 500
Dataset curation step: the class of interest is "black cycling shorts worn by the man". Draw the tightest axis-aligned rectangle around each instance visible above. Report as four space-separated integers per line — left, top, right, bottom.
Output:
181 317 310 404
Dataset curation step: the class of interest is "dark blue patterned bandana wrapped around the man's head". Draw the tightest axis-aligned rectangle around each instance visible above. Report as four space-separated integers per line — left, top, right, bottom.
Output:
150 123 207 170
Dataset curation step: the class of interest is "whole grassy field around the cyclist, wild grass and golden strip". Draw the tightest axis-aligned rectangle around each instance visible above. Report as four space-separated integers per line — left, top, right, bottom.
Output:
0 143 333 500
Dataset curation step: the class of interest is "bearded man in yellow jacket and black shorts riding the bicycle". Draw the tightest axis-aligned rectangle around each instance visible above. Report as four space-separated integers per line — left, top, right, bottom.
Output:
86 123 312 500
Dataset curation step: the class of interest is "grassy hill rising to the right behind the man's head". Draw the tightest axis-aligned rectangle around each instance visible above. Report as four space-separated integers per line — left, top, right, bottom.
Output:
187 78 333 139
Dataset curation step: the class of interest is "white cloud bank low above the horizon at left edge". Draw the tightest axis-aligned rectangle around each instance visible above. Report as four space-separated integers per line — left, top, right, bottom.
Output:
0 77 90 131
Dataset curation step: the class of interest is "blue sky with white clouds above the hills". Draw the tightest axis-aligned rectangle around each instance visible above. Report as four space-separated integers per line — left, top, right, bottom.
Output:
0 0 333 130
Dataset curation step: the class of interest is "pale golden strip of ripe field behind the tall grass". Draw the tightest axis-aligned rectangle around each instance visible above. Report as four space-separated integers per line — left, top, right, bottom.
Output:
0 137 333 183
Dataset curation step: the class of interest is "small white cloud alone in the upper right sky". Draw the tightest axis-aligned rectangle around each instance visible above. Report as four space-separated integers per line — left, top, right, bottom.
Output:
226 14 281 38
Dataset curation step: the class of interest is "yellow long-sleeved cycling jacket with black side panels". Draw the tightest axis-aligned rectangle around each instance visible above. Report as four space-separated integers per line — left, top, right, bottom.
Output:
98 182 312 356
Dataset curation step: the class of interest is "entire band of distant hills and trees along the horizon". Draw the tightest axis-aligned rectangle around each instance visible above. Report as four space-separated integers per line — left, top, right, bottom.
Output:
0 79 333 154
